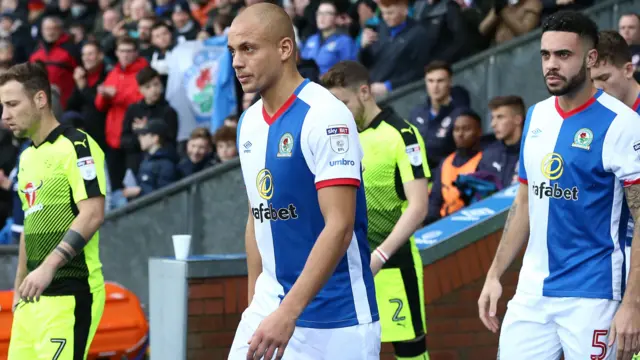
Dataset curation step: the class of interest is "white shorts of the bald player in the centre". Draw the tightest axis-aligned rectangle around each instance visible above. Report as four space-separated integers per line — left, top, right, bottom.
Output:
229 309 380 360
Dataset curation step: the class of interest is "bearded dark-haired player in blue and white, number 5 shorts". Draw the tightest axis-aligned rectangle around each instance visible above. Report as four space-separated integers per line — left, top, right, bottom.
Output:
478 12 640 360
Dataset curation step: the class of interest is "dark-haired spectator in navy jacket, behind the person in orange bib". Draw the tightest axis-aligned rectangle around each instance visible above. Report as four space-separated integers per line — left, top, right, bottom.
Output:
409 61 469 173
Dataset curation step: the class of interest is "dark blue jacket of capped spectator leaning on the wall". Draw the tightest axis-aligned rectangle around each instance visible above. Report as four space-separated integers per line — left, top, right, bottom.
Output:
138 147 179 196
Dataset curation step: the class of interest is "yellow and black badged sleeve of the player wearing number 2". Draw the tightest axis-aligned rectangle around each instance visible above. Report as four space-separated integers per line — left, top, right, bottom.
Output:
396 121 431 184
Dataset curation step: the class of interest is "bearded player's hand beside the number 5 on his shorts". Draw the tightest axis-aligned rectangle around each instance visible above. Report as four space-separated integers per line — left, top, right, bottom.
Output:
609 302 640 360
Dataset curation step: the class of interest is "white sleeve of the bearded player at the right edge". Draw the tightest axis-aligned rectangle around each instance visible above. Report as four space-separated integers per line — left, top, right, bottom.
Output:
602 111 640 186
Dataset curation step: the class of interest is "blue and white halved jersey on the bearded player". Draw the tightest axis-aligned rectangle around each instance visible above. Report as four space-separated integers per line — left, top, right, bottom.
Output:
518 90 640 300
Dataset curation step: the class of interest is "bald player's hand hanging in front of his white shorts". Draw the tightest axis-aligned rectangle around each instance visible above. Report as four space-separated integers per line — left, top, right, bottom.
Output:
247 308 296 360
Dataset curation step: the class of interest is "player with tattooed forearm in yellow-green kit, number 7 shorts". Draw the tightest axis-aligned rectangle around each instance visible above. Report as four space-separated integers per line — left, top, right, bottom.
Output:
0 63 106 360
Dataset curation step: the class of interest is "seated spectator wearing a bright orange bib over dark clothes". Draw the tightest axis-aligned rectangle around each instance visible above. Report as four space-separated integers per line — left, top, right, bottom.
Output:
425 110 482 224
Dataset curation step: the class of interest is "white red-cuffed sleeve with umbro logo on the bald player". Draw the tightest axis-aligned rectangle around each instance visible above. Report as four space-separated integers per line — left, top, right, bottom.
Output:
301 101 363 189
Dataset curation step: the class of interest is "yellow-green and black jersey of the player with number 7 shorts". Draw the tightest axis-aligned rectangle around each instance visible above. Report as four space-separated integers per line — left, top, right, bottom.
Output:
18 125 106 295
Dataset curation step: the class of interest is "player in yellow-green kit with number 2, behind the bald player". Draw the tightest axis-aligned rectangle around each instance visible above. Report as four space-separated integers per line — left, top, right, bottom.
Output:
322 61 431 360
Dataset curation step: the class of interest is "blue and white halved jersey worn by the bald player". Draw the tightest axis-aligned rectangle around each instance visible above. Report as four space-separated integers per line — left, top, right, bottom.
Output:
237 80 378 328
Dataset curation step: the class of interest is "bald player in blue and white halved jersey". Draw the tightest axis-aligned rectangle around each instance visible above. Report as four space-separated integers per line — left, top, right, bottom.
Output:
228 3 380 360
